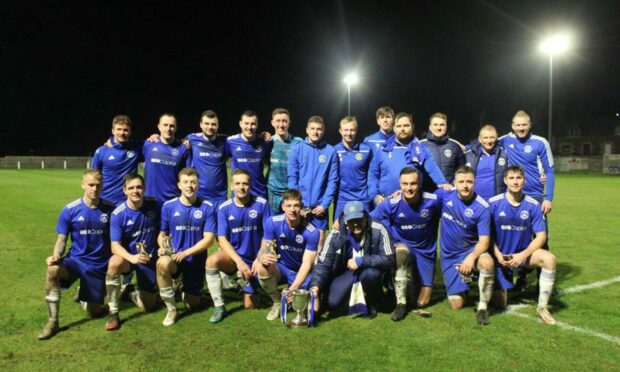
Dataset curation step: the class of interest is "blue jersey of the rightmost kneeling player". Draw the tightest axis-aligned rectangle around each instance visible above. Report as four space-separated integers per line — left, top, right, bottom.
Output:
489 194 546 254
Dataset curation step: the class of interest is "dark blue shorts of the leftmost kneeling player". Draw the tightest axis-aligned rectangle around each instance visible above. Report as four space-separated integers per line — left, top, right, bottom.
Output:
60 257 108 304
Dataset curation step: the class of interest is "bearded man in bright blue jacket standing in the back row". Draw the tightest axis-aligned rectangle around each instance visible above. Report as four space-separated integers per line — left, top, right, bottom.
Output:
368 112 446 205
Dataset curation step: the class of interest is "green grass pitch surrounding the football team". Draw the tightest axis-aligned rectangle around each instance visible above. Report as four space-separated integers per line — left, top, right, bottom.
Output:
0 170 620 370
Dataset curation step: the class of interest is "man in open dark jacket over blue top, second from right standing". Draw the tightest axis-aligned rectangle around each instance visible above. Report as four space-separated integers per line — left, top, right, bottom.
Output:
465 124 508 201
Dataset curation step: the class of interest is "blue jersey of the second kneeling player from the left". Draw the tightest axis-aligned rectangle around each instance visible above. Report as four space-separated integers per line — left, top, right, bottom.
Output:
110 200 160 257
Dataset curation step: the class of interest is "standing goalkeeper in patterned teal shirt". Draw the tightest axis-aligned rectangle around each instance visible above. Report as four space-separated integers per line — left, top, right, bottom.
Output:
267 108 303 214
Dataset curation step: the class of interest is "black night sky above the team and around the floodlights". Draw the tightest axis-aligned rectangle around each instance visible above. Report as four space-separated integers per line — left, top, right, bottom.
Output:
0 0 620 156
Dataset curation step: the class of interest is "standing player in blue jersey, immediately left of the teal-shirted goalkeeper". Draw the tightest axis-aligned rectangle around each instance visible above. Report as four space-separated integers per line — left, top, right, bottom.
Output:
226 111 273 200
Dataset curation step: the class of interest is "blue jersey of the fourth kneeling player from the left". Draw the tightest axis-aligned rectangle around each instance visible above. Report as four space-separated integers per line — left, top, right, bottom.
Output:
217 196 271 264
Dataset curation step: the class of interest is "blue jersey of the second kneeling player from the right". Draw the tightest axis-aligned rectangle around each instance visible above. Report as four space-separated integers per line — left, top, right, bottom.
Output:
436 189 491 258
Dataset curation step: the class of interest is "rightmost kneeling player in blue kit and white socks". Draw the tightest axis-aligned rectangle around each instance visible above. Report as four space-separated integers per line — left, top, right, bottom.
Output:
490 165 556 324
